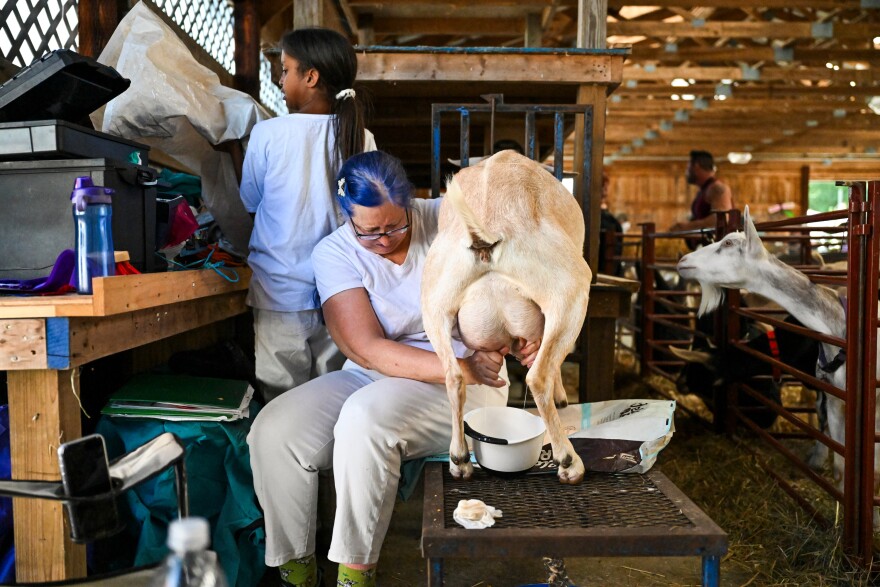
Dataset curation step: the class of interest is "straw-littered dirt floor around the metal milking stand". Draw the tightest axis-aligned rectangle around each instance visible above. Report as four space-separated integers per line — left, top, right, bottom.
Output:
298 358 880 587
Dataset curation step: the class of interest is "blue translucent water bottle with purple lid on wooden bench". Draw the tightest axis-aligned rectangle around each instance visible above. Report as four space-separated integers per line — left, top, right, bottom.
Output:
70 176 116 294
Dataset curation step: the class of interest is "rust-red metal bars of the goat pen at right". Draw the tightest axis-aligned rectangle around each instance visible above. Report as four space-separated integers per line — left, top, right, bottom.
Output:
639 181 880 567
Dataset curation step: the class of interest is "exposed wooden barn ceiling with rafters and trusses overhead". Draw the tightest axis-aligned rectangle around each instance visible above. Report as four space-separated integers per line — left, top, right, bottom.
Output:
272 0 880 165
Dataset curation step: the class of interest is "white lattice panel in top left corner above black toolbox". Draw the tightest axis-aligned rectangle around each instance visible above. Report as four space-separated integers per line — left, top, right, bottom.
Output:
0 0 79 67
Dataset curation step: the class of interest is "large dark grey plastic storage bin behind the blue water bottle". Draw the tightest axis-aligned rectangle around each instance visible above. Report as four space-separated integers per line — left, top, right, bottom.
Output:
0 159 164 279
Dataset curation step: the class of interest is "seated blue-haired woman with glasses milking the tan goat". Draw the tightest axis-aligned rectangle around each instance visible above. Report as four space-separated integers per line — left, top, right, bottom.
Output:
248 151 508 587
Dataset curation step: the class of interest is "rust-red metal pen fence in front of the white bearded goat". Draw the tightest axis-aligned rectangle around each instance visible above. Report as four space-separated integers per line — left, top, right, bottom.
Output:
635 181 880 565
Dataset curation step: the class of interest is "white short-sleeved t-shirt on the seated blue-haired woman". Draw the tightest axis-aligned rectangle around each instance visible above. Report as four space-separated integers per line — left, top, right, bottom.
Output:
312 199 470 357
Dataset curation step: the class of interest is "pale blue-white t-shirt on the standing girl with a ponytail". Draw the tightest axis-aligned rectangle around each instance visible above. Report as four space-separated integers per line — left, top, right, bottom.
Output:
241 114 376 312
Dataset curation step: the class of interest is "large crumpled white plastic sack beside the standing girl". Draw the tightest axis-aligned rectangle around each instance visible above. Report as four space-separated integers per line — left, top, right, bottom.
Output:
92 2 270 255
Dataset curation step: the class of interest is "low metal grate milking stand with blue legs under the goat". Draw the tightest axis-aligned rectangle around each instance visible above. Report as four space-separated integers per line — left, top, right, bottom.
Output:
422 462 727 587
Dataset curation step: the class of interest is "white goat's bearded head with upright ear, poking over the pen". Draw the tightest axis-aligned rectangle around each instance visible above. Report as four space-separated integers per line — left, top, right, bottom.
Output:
676 206 769 316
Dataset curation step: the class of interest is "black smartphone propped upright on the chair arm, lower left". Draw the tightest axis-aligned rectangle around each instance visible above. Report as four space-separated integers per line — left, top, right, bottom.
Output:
58 434 122 543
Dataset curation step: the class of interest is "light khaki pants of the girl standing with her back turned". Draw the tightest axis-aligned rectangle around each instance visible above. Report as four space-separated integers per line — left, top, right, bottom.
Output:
254 308 345 402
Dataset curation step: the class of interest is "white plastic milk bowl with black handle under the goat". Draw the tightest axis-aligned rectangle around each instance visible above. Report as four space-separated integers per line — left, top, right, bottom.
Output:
464 407 546 473
